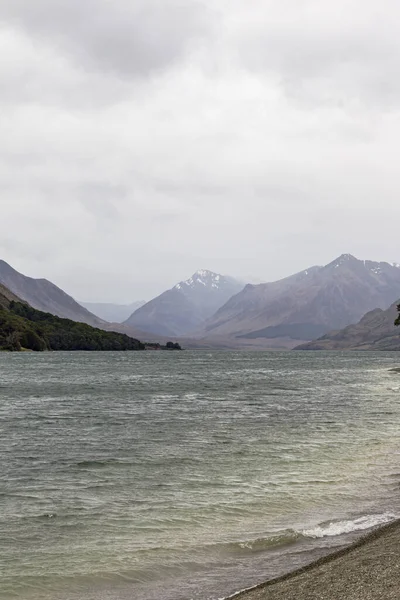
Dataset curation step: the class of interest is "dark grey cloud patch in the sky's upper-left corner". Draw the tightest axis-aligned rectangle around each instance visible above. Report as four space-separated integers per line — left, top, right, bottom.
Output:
0 0 212 77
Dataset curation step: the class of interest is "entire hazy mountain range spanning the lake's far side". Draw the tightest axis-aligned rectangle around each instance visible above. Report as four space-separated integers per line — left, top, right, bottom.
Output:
0 254 400 349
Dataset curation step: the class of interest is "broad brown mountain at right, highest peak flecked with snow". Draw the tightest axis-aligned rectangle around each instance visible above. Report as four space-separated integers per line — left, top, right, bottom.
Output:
202 254 400 347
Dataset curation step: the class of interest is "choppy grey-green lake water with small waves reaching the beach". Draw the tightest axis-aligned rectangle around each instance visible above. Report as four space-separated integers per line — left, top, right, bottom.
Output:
0 351 400 600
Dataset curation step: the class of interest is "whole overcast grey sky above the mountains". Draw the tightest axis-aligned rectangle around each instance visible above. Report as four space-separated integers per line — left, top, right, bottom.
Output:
0 0 400 302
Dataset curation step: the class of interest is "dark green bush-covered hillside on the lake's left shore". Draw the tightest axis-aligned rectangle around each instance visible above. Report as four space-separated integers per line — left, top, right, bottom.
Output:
0 300 144 352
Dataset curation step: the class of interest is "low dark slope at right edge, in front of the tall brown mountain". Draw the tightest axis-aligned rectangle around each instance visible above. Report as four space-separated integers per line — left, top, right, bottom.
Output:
295 301 400 350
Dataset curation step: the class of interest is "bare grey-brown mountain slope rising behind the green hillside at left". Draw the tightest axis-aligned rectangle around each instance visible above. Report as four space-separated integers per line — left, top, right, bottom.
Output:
0 260 104 327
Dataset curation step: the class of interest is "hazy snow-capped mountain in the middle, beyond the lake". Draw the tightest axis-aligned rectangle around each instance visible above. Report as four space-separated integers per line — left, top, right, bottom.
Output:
124 270 243 336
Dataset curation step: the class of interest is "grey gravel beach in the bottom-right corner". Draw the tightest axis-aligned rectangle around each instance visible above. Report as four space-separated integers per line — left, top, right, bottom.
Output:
230 519 400 600
